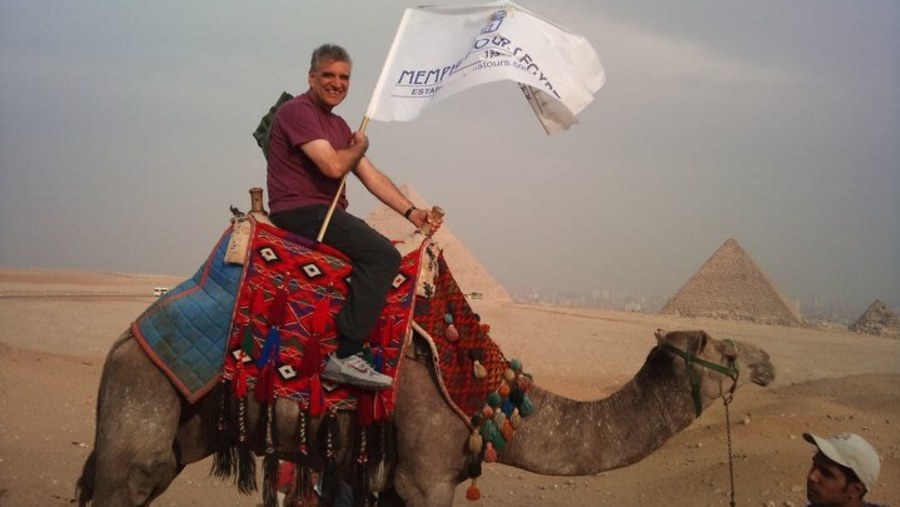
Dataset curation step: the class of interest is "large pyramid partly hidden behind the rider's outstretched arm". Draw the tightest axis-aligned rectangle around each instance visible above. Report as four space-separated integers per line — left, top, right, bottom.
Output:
366 188 513 301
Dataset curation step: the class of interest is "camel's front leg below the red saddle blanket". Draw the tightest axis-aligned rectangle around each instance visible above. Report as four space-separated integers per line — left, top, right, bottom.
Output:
394 359 468 507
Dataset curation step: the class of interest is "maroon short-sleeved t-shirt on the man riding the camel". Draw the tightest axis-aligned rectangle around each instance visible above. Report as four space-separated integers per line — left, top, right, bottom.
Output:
266 92 353 213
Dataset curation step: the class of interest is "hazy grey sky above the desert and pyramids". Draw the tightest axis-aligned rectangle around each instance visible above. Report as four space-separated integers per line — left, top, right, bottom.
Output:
0 0 900 313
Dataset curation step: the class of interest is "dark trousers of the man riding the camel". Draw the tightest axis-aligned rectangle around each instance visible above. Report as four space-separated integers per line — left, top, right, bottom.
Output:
269 204 401 357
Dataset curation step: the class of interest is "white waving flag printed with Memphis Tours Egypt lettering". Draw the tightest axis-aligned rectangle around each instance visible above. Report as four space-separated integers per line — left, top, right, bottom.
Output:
366 1 606 134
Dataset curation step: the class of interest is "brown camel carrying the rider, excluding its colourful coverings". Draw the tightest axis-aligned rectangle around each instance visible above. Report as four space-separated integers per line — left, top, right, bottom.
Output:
78 324 775 507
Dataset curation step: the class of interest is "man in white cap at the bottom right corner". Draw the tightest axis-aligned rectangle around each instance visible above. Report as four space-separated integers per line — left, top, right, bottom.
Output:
803 433 881 507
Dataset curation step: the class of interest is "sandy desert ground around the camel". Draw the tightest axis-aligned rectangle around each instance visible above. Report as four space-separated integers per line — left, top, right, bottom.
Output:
0 269 900 507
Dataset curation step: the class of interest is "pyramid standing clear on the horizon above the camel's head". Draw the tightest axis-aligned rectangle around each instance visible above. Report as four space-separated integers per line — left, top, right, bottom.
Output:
660 238 802 326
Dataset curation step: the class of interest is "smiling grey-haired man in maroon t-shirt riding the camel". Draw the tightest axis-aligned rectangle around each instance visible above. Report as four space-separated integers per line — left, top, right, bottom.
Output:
266 44 442 389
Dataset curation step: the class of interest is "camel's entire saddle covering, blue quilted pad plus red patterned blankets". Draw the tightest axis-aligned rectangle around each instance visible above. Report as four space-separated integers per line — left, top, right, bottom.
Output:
133 212 519 430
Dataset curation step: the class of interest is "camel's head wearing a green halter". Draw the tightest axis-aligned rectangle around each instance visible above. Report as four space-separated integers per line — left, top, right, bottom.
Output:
656 329 775 394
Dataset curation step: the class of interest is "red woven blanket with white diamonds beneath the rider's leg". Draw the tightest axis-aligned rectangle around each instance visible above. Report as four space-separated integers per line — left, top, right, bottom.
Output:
223 220 431 420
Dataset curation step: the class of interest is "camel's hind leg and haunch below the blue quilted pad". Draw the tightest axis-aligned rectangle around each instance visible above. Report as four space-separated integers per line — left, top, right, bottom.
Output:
93 337 181 507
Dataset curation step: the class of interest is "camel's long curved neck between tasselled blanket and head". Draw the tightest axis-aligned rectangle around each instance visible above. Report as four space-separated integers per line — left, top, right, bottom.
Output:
500 354 695 475
